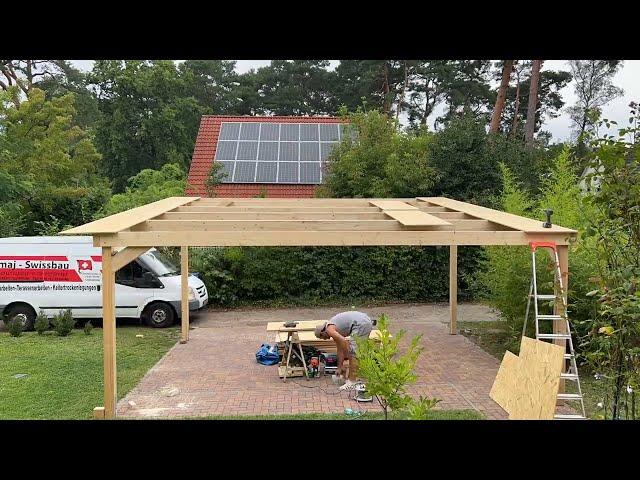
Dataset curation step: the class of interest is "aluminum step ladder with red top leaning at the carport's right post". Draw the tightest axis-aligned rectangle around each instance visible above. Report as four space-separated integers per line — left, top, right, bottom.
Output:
522 242 586 420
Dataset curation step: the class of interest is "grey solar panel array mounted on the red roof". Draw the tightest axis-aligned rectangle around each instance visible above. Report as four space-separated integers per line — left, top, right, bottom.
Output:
215 122 346 184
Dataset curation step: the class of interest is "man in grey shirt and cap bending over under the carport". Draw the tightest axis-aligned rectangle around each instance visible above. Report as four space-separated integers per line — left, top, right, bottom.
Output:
314 311 375 390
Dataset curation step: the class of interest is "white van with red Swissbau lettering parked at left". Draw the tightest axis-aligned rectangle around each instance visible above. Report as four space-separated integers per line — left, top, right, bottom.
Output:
0 236 209 330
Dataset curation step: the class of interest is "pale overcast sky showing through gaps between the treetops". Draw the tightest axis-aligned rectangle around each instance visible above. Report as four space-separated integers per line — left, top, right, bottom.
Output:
71 60 640 142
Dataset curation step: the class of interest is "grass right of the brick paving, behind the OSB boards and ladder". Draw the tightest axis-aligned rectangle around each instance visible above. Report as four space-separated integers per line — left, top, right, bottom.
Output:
458 321 624 419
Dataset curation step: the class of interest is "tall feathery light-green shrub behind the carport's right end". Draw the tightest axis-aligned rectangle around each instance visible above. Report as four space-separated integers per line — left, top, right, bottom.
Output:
472 149 596 350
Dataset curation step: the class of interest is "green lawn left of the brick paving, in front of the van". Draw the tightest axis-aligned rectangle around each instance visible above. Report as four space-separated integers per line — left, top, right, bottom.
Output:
0 326 180 419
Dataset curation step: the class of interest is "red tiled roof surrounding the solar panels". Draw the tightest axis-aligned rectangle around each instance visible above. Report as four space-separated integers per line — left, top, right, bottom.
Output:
185 115 347 198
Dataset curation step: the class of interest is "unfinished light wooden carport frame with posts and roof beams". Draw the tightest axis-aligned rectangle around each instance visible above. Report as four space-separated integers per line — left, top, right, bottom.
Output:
62 197 576 418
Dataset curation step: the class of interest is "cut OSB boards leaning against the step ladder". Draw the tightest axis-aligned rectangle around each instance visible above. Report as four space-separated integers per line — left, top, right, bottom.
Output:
489 337 564 420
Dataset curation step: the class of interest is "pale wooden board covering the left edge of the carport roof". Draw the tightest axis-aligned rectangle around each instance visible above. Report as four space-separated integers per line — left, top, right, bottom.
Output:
60 197 198 235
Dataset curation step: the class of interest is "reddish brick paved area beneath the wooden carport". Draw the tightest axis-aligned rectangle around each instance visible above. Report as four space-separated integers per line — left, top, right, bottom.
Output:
118 304 507 419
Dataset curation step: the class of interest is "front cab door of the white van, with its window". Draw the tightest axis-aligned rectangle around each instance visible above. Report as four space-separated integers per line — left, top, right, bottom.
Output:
116 260 161 318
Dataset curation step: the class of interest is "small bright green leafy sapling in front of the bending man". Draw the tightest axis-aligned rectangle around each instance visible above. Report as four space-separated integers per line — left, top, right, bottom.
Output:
356 315 422 420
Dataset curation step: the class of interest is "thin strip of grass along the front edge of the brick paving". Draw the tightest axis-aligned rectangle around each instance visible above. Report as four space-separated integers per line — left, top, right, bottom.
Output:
199 410 485 420
